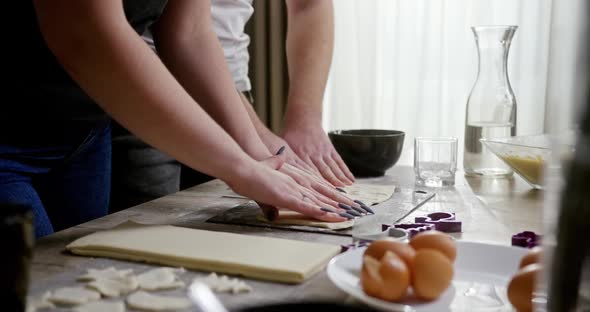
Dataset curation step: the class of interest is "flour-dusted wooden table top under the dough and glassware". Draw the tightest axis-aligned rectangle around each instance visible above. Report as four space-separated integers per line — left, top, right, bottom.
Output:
30 166 544 309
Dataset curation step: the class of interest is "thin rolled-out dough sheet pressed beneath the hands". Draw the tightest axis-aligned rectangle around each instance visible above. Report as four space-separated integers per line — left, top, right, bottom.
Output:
256 182 395 230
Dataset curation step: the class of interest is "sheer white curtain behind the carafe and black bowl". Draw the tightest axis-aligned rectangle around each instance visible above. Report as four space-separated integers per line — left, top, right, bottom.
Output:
323 0 580 168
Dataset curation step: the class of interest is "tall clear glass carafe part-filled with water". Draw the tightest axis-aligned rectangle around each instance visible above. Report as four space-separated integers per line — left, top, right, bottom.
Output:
463 26 517 177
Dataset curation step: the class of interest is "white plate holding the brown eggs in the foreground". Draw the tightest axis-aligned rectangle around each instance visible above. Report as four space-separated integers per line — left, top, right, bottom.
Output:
328 241 527 311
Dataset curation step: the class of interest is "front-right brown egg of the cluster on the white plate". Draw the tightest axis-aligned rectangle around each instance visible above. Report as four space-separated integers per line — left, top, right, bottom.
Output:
411 248 454 300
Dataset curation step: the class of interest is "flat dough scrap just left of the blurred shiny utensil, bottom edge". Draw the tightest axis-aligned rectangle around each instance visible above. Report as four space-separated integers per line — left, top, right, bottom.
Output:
127 290 192 311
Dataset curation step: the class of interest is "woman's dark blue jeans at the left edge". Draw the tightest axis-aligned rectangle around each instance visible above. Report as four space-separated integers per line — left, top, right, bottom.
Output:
0 122 111 237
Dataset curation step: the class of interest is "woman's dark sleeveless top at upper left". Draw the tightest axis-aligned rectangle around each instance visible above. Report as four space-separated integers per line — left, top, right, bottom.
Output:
0 0 167 130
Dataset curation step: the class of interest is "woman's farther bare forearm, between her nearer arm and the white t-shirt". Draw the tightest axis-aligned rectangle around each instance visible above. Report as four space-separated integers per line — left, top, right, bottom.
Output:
154 1 271 160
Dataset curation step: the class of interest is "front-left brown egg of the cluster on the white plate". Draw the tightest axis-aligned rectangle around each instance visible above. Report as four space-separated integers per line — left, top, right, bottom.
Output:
361 251 410 301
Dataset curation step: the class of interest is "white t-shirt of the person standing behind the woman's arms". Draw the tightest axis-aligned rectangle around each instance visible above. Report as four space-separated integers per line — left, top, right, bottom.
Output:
142 0 254 92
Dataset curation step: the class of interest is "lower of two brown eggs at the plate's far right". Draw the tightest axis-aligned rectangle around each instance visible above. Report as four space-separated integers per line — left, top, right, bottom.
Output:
508 263 542 312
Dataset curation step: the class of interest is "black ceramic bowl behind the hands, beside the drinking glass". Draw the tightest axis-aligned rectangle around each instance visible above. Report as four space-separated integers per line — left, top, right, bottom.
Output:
328 129 405 177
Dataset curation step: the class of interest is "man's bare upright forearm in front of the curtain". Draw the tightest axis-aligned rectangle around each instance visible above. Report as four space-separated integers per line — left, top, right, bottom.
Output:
285 0 334 128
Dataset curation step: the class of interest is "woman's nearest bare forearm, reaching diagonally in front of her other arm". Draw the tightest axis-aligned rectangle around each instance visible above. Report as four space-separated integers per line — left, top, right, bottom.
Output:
35 0 255 181
